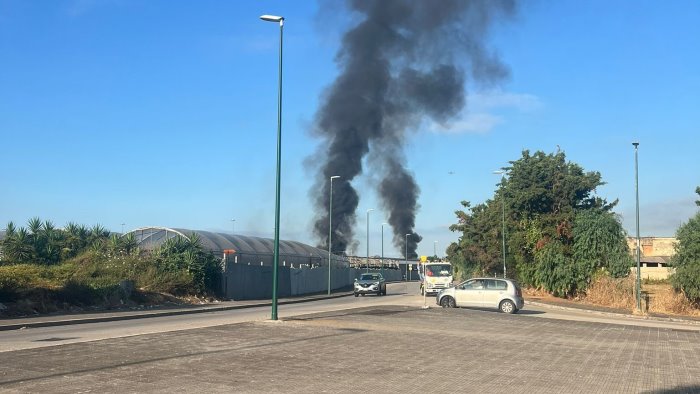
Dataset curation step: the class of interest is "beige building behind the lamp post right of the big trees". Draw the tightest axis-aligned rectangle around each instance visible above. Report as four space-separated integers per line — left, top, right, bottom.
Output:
627 237 678 279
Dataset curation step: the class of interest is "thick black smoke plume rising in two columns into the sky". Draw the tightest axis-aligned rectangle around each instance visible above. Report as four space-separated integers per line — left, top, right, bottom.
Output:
311 0 515 258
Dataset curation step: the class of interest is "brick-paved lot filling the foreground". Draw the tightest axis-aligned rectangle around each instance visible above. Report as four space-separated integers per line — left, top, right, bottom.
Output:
0 307 700 393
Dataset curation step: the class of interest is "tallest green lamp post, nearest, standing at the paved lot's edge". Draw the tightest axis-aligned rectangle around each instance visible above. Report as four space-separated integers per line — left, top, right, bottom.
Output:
260 15 284 320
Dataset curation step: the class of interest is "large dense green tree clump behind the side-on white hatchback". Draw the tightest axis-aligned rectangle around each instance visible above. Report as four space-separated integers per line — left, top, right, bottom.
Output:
448 150 632 296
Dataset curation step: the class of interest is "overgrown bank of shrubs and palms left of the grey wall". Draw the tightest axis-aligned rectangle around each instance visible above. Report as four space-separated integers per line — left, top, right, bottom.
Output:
0 218 219 314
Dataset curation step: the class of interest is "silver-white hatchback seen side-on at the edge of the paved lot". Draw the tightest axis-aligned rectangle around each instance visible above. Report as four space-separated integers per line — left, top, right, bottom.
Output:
435 278 525 313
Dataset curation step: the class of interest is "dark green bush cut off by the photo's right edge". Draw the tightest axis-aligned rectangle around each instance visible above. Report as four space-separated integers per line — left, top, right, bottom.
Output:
671 209 700 304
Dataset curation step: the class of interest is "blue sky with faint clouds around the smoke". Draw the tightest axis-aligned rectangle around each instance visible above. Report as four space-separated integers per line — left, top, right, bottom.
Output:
0 0 700 257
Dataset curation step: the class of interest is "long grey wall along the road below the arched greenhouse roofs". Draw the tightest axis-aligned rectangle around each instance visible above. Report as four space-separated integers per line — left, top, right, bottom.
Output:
221 262 403 300
